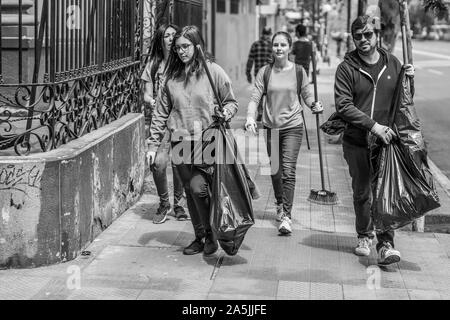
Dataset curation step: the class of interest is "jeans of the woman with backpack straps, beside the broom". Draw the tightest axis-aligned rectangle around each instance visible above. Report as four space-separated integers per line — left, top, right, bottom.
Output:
265 124 303 218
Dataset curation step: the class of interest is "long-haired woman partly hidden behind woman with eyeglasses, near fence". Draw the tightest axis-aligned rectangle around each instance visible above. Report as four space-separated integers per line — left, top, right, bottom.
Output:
141 24 188 224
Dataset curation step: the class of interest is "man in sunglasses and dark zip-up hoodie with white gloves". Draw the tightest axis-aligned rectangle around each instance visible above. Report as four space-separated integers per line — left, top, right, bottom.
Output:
335 15 414 265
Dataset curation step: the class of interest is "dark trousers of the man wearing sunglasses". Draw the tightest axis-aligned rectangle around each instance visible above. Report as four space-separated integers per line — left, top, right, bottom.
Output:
343 141 394 250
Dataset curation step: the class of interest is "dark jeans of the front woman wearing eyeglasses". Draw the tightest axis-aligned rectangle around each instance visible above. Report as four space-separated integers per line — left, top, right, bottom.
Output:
172 141 212 239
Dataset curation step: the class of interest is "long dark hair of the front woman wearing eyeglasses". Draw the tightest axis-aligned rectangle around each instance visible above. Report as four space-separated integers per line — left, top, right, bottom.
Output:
166 26 212 79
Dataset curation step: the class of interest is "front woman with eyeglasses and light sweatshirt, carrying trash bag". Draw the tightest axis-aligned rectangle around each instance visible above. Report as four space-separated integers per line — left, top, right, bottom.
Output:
147 26 238 255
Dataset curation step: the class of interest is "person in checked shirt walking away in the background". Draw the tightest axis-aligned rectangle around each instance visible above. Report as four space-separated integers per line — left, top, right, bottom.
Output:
246 27 272 121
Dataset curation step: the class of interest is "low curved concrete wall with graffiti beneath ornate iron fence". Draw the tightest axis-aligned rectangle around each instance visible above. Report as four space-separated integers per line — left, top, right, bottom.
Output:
0 113 144 268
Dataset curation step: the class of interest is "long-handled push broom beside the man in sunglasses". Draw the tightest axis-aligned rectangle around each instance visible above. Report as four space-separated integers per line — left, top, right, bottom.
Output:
308 48 338 205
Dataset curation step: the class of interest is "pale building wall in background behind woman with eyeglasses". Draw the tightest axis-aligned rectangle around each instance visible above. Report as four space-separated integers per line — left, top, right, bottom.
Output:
215 0 256 82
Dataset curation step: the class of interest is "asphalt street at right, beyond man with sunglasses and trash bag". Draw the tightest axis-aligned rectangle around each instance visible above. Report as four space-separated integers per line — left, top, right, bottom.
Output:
394 40 450 177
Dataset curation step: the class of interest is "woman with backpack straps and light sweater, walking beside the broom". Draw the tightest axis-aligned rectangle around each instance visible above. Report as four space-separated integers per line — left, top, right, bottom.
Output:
245 31 323 234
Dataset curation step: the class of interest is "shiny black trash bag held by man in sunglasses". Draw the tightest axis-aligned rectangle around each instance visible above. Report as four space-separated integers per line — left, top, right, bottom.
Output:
372 69 440 231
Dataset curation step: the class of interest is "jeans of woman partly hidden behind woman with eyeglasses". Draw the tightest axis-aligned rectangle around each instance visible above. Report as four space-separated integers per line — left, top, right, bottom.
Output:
152 132 183 207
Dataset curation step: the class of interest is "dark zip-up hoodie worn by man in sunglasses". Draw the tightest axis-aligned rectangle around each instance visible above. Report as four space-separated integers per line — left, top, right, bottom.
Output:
334 48 402 146
